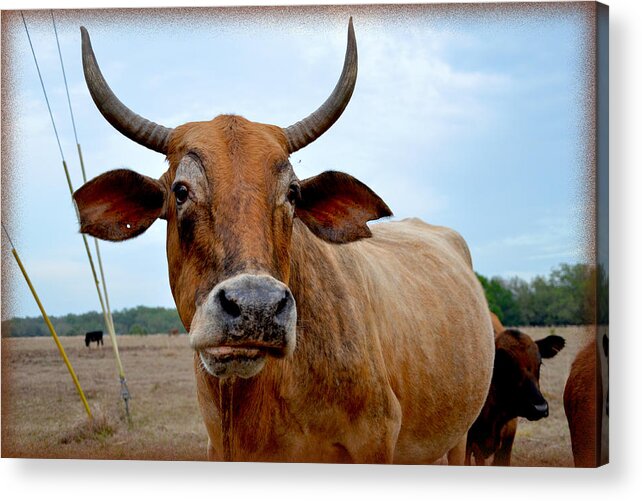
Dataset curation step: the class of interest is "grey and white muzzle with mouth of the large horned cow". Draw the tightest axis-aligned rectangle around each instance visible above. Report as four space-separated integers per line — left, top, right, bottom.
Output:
190 274 296 378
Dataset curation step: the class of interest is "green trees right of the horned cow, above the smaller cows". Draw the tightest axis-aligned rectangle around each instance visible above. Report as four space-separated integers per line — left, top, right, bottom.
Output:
477 264 608 326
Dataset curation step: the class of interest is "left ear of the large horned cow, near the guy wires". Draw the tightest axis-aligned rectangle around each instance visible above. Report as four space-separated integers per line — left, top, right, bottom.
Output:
74 169 166 240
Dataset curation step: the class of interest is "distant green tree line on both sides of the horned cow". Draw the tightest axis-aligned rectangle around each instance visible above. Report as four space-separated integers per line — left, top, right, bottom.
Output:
2 264 608 337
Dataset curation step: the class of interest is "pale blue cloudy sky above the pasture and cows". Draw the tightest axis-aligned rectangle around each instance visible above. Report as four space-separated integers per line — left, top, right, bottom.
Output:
2 7 588 316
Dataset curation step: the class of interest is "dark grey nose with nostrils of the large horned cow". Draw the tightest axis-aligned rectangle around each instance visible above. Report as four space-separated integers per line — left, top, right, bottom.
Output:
215 275 295 336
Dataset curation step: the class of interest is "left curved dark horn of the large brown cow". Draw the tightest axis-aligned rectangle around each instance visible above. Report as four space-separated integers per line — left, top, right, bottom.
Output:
80 26 173 153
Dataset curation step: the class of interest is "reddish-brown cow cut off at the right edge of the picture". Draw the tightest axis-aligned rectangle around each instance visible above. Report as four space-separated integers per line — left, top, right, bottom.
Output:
564 332 609 468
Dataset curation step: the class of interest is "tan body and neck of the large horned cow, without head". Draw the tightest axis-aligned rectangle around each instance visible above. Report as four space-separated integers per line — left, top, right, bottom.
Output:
195 220 494 463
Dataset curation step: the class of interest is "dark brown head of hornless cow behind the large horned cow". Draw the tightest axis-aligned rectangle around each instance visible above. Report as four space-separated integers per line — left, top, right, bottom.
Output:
493 329 565 421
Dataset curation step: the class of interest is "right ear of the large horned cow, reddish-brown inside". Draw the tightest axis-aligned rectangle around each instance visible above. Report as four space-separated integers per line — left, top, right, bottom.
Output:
295 171 392 243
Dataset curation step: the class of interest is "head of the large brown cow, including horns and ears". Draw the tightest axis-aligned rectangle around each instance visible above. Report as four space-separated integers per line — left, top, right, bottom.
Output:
74 21 391 377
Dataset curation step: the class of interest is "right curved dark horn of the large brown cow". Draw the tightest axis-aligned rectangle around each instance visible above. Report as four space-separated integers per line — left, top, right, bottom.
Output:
284 17 357 153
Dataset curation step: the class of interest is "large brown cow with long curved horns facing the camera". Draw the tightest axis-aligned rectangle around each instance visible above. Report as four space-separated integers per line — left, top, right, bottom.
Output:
74 21 493 463
